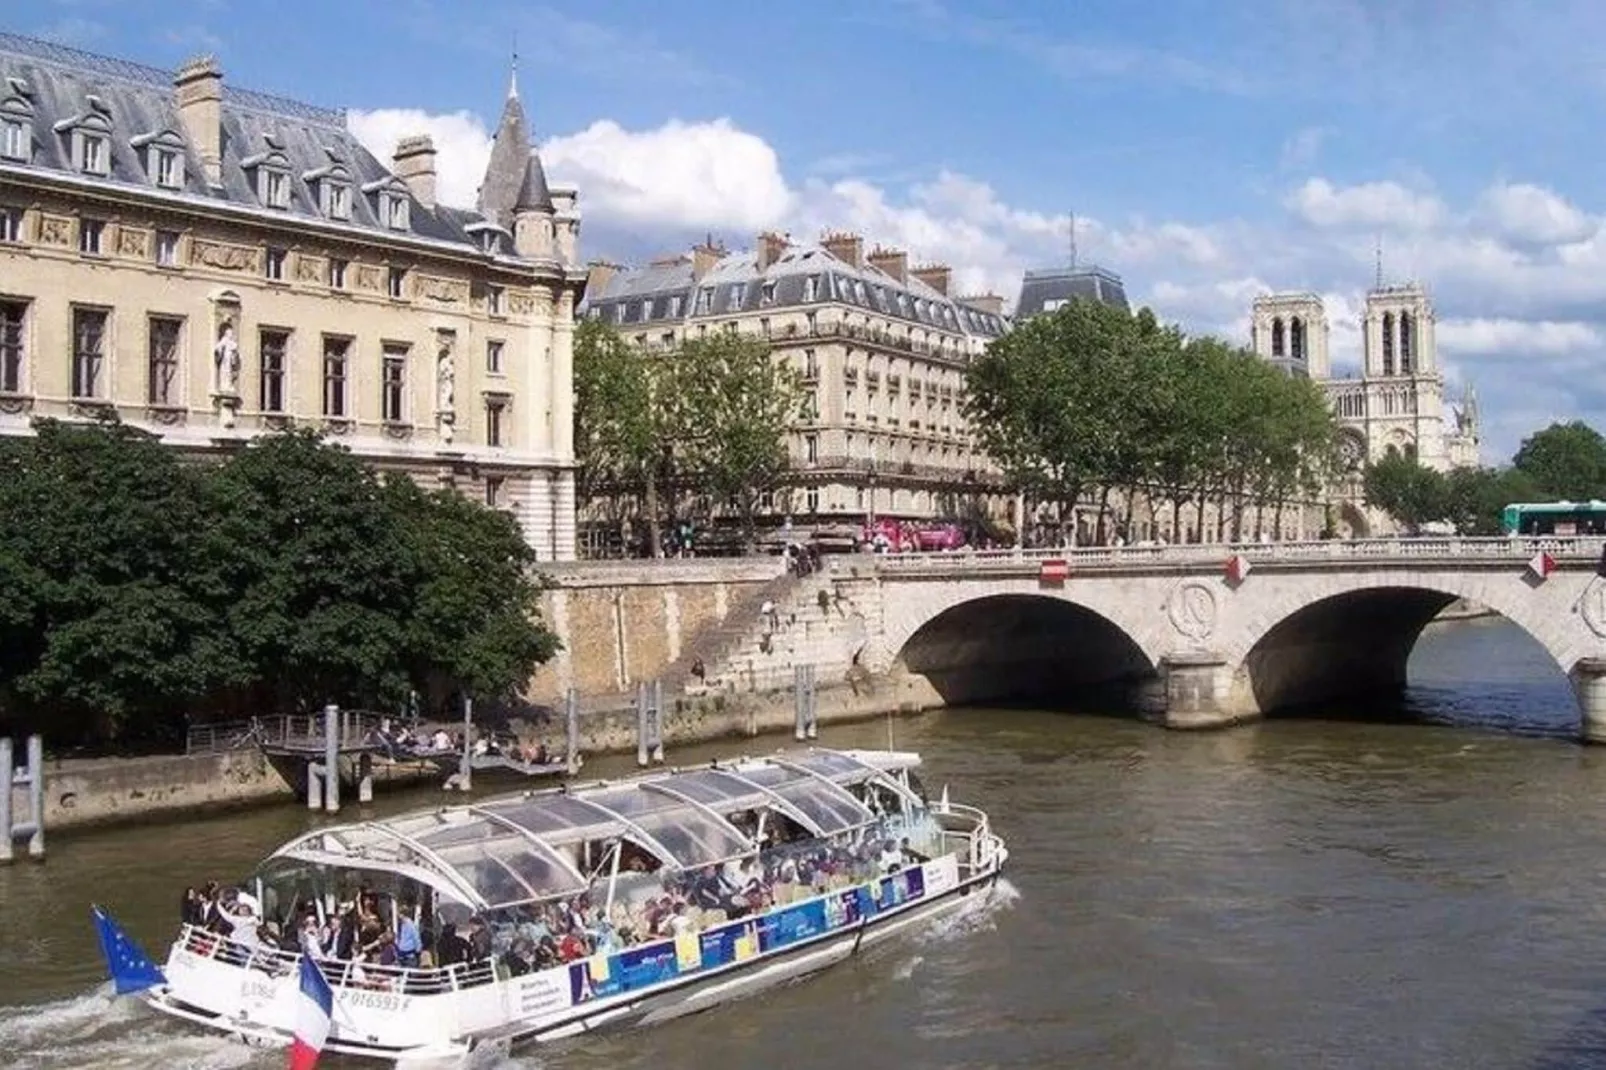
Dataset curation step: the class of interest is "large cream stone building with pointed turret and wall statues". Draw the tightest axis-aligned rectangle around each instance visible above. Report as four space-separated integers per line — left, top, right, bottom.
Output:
0 34 585 559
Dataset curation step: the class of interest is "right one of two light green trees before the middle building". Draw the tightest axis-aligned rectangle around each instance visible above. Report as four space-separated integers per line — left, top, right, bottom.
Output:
660 331 813 549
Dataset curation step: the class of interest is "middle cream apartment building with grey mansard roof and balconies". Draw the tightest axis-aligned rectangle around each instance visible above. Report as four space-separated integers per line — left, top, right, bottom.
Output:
585 233 1007 529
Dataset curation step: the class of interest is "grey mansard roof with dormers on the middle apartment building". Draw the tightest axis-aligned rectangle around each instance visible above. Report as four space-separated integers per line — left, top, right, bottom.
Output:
583 243 1007 339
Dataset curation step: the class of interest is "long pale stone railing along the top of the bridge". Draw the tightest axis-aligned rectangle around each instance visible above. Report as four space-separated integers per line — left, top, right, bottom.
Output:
854 535 1606 572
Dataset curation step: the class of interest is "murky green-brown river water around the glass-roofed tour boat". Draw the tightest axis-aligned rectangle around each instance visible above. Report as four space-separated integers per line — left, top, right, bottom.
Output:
0 622 1606 1070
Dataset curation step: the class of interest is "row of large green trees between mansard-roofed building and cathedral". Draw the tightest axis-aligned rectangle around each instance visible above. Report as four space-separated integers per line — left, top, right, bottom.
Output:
965 300 1338 538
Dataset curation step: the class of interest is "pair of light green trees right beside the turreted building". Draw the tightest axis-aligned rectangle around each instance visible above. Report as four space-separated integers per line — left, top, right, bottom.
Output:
575 318 805 554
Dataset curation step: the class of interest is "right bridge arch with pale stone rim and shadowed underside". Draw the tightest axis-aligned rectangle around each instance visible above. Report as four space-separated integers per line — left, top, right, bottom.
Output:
1221 569 1593 713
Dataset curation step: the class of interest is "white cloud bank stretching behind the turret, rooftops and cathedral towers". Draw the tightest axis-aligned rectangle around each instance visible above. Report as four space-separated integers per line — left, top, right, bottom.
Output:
350 109 1606 461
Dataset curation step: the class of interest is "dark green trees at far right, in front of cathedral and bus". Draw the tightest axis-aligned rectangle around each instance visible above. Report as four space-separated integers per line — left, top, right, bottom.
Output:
1365 421 1606 535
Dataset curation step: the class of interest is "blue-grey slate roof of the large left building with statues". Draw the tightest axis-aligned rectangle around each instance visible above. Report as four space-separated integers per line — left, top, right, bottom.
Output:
0 34 522 249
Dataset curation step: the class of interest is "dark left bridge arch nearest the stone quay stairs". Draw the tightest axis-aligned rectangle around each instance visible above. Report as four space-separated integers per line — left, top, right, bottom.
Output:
887 583 1160 705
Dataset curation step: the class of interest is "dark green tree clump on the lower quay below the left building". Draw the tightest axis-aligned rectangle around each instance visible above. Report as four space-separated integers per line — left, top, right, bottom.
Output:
0 419 557 745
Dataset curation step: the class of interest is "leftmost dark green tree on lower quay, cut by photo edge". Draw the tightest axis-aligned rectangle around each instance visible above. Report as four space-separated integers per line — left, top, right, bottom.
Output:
0 419 241 742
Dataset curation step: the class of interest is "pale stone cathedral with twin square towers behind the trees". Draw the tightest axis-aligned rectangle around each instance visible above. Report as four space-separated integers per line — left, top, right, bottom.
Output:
1251 283 1481 533
